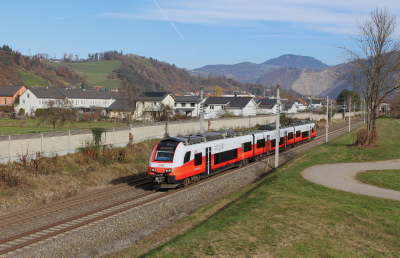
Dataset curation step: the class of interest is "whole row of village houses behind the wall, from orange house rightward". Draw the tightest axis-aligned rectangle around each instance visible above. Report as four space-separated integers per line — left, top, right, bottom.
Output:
0 86 321 120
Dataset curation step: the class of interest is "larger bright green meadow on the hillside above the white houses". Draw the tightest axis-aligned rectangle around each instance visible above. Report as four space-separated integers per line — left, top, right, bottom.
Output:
49 60 122 88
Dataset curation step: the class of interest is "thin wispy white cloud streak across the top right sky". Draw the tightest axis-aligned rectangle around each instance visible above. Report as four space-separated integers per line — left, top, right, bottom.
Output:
102 0 400 34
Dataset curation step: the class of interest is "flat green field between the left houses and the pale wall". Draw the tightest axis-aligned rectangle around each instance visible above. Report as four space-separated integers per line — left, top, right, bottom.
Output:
0 118 126 135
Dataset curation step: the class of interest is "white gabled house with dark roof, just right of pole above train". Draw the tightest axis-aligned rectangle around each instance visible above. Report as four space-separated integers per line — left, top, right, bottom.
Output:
204 97 258 119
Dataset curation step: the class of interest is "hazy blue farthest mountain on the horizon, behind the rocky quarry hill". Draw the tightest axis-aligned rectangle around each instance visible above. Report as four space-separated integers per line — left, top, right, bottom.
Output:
192 55 329 83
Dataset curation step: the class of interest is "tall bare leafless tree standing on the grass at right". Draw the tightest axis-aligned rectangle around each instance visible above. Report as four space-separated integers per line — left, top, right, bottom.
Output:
341 7 400 145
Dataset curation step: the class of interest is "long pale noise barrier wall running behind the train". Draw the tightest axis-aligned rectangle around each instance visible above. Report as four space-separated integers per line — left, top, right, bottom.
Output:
0 112 360 163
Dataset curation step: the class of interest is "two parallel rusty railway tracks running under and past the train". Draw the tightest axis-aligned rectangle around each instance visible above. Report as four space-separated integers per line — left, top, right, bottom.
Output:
0 119 363 255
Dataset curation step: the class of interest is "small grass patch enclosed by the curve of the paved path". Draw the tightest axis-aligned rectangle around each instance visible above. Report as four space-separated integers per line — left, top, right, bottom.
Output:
357 170 400 191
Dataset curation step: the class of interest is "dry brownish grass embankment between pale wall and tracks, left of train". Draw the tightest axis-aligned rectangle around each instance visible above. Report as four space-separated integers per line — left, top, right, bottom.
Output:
0 139 159 215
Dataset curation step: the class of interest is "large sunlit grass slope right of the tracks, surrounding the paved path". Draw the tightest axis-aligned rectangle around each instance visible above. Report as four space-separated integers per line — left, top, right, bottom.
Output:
110 119 400 257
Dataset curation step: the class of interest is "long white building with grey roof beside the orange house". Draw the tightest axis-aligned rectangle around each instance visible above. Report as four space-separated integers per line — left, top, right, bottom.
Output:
17 87 117 115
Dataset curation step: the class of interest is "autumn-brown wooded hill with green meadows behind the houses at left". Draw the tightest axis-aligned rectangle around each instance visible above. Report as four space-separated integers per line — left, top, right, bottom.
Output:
0 46 263 94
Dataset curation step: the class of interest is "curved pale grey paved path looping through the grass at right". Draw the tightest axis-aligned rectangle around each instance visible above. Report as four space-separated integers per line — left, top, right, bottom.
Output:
302 159 400 201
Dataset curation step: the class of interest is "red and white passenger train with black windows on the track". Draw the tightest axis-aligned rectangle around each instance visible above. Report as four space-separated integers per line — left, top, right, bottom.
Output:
148 120 316 188
